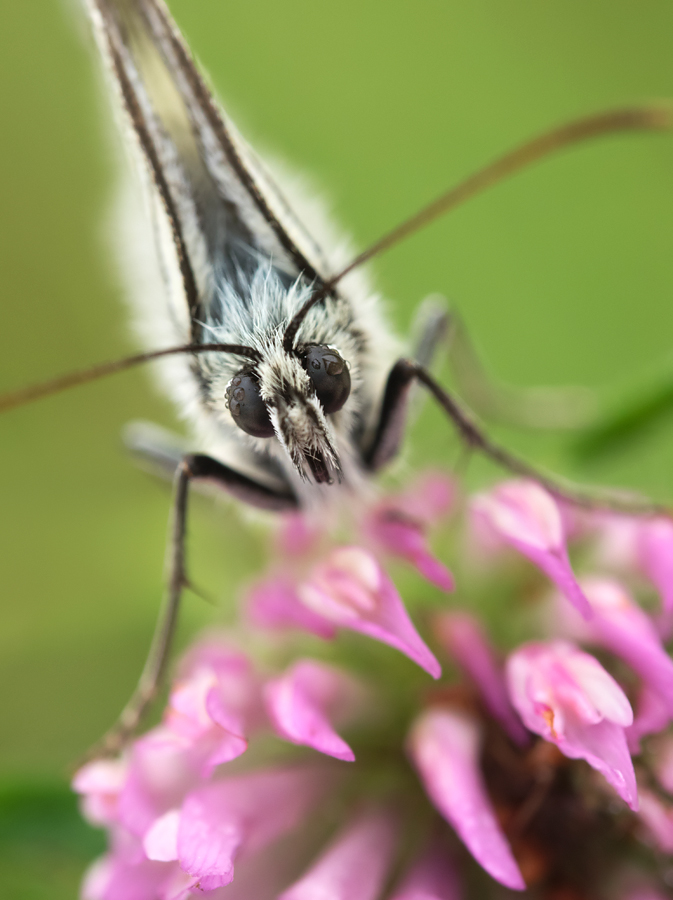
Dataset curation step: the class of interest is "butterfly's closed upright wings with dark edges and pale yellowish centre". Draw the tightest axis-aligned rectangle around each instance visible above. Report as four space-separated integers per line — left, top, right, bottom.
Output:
88 0 330 342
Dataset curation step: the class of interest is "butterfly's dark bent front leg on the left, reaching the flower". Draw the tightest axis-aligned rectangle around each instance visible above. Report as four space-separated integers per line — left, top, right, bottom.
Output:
89 454 297 758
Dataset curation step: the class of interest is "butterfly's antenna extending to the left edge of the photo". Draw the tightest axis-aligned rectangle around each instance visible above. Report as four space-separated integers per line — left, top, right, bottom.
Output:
0 344 261 413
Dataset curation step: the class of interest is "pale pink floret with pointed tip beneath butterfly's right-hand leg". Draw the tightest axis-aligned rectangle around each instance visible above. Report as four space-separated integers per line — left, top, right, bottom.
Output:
472 481 591 619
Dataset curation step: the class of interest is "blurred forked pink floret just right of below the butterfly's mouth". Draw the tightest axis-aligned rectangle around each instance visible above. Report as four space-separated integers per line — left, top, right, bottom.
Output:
363 473 455 591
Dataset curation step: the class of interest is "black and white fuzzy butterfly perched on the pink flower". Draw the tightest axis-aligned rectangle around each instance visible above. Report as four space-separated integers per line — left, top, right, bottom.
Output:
0 0 671 750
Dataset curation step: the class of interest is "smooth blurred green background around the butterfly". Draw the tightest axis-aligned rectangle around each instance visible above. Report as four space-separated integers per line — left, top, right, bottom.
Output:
0 0 673 900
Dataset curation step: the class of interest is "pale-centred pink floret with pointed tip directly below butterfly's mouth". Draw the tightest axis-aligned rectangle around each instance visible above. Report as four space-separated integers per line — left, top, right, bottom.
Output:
298 547 442 678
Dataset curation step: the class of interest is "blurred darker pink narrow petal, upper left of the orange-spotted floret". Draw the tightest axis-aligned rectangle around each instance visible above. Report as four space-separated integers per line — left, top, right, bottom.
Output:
435 613 530 747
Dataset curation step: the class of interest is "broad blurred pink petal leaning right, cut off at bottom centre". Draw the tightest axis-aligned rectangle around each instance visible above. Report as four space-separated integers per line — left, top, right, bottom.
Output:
279 811 397 900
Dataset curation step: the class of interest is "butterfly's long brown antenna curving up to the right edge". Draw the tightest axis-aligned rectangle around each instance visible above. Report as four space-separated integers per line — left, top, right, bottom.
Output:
283 101 673 352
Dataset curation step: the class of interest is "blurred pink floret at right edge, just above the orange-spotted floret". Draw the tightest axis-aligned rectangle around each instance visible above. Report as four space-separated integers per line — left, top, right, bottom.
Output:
565 578 673 715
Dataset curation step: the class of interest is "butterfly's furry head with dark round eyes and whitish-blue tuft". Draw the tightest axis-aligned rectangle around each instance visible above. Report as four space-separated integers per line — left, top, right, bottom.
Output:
197 265 362 484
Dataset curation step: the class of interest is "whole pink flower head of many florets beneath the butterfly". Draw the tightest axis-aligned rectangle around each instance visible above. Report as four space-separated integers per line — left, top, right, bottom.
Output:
74 474 673 900
